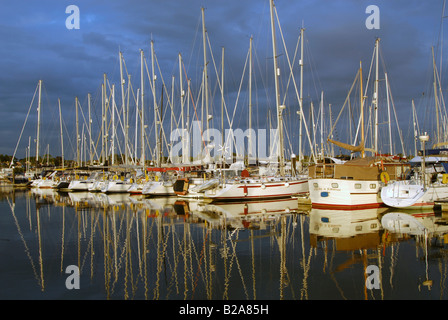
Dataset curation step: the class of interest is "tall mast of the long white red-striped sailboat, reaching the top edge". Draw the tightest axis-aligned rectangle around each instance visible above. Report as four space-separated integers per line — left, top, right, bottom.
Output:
269 0 285 175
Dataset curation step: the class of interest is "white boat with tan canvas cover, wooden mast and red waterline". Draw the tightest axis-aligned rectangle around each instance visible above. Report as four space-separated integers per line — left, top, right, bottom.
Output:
309 39 409 210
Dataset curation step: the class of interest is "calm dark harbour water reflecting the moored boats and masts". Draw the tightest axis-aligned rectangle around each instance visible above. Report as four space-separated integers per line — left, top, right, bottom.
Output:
0 189 448 300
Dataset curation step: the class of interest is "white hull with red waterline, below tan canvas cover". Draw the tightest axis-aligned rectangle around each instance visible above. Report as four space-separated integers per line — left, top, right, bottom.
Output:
309 179 384 210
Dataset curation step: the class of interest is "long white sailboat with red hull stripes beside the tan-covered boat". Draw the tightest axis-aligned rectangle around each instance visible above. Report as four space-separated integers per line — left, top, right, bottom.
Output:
204 0 308 201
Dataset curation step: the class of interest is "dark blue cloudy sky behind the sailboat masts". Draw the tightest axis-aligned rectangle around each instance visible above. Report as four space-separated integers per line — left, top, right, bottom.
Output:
0 0 448 162
